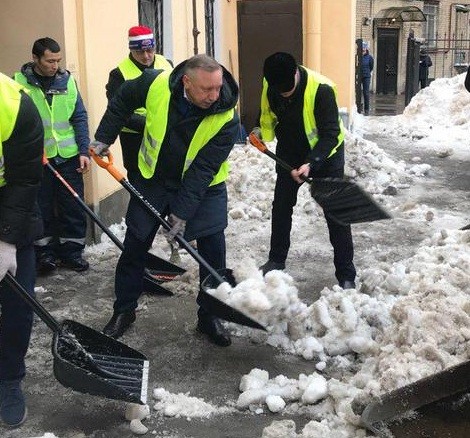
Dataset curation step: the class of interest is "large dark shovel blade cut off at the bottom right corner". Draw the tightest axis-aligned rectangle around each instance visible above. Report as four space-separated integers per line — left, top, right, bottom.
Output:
353 361 470 437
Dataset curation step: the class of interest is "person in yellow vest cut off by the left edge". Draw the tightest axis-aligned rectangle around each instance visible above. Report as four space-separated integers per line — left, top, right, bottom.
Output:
0 73 44 427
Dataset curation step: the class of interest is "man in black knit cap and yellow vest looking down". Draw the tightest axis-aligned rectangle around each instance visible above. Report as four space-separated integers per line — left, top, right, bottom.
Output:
255 52 356 289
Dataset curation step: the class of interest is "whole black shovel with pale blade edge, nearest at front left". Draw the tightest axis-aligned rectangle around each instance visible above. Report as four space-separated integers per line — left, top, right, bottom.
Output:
4 273 149 404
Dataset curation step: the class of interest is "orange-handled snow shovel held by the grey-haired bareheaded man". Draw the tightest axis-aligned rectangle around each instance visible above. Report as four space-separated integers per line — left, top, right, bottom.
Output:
90 151 266 330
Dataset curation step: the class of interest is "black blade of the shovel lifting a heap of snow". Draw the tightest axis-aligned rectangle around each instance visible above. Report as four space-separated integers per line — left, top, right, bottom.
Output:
199 269 266 331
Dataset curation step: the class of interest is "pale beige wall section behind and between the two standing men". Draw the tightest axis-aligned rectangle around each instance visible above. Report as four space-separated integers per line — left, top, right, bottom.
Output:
70 0 138 205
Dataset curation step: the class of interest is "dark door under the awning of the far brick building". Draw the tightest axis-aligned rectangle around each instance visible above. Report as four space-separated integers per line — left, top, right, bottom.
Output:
375 28 400 94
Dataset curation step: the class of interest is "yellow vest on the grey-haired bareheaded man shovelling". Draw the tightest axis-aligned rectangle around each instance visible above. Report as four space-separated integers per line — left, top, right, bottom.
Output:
139 71 235 186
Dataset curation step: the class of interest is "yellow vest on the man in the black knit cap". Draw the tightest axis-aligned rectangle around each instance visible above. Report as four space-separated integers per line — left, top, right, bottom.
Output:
260 67 346 158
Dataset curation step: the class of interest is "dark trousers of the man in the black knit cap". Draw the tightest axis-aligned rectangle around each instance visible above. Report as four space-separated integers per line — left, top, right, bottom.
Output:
269 170 356 281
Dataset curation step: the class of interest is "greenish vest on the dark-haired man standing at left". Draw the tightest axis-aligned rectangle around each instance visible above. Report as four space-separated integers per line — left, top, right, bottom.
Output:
15 72 79 158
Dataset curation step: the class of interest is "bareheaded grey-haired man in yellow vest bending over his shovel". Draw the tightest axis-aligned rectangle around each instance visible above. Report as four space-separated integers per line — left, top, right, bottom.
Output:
91 54 238 347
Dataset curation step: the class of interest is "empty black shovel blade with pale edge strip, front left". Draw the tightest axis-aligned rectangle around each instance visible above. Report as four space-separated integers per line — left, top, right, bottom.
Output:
52 320 149 404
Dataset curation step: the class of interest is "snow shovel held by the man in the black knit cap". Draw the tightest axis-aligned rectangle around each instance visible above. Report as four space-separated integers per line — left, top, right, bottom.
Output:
249 132 391 225
